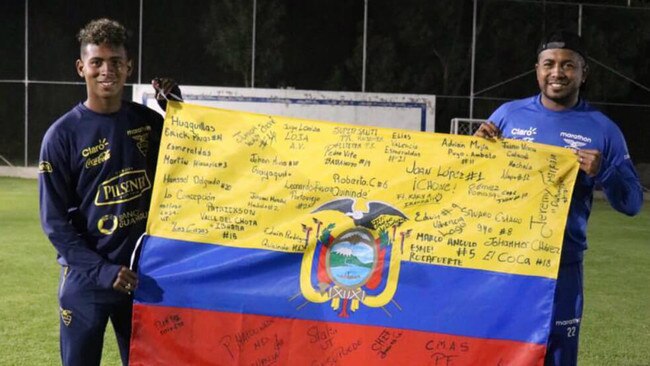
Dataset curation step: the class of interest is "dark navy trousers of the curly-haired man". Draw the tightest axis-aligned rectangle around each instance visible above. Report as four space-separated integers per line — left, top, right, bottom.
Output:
59 266 133 366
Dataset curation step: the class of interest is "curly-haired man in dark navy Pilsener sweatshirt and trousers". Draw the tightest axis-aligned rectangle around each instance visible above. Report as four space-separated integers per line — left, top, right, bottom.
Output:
39 19 179 365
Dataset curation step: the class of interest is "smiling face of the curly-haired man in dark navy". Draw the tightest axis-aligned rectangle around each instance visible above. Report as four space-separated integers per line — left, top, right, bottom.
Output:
76 43 132 113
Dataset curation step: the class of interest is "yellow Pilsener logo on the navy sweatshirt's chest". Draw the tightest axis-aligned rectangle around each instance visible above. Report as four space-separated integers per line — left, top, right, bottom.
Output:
95 170 151 206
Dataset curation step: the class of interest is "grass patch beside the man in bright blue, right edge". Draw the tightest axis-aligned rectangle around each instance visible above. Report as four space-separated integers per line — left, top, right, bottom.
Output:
580 194 650 366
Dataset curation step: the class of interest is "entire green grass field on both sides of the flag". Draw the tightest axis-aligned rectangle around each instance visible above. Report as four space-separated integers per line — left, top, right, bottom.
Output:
0 177 650 366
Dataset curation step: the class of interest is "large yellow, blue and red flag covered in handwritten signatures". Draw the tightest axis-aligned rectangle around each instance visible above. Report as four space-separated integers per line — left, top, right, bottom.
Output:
130 102 578 366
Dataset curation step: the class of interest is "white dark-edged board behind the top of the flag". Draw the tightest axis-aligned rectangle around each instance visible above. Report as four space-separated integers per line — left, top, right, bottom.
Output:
133 84 436 132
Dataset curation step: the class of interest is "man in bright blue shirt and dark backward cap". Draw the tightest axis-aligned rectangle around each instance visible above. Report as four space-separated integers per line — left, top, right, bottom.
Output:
475 31 643 366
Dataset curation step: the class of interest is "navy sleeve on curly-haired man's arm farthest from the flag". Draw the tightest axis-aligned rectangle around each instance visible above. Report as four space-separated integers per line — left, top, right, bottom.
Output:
38 131 121 288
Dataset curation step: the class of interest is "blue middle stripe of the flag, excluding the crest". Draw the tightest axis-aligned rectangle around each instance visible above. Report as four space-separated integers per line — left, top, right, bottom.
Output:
136 236 555 344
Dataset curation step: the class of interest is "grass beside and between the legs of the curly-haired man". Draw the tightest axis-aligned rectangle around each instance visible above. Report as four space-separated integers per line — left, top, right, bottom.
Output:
0 177 121 366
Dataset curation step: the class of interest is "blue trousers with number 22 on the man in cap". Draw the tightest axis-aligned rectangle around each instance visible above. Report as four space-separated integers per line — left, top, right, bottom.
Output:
544 261 583 366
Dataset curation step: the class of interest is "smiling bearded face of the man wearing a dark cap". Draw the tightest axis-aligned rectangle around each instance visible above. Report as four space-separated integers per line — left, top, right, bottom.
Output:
535 48 587 111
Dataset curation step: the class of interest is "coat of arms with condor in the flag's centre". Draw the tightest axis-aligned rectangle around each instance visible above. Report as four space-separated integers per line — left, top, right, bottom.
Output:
300 198 408 318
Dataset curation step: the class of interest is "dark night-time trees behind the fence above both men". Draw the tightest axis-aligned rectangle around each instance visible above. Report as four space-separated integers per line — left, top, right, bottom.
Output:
0 0 650 163
